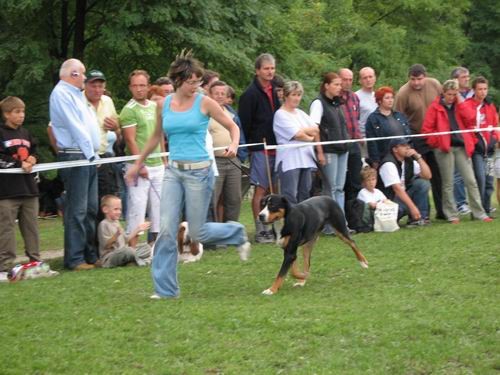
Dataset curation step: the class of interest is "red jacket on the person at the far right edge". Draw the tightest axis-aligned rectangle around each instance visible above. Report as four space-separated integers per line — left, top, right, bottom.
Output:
461 97 499 152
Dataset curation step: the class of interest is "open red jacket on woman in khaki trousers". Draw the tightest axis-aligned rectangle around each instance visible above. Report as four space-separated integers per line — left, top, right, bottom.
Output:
421 96 476 157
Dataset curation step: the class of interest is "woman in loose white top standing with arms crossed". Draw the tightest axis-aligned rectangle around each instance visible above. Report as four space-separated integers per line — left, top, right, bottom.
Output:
273 81 319 204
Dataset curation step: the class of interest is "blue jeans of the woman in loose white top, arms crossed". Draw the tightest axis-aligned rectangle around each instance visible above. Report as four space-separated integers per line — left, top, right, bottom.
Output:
279 164 312 204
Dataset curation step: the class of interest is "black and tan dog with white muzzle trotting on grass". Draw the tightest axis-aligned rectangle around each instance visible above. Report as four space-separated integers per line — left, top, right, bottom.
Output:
259 194 368 295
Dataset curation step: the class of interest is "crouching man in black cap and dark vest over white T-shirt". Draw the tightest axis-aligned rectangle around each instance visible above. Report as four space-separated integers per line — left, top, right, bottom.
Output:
379 138 432 226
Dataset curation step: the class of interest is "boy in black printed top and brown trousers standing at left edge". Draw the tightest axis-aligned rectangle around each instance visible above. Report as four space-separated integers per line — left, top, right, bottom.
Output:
0 96 41 282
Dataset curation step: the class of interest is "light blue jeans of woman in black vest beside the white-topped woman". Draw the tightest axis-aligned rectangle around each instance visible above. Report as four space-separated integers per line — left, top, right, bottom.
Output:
321 152 349 211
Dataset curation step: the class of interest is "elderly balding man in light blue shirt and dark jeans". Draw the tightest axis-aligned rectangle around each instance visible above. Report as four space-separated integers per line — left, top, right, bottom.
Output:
49 59 100 271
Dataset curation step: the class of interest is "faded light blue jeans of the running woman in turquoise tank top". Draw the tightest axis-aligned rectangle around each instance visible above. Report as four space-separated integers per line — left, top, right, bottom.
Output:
151 166 247 297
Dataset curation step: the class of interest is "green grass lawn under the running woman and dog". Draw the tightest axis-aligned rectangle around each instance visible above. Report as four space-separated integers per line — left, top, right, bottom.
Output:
0 201 500 374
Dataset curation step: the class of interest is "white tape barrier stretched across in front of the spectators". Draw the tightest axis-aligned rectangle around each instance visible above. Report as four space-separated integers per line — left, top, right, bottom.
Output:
0 126 500 174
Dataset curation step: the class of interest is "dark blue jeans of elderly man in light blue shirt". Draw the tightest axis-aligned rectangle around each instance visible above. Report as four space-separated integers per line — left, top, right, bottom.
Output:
57 153 98 269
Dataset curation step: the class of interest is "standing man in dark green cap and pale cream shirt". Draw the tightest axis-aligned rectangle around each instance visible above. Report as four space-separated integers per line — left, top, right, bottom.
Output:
85 70 120 200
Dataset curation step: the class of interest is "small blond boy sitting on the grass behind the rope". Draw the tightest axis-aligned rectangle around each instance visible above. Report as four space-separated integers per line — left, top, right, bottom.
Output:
97 195 152 268
